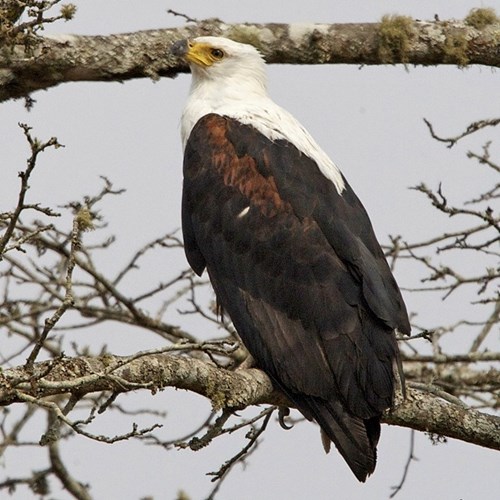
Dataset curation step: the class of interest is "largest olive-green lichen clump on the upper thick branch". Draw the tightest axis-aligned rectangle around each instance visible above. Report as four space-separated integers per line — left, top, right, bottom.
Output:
377 15 415 64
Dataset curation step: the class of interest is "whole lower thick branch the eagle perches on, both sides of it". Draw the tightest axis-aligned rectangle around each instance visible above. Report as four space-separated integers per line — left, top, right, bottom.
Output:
0 352 500 450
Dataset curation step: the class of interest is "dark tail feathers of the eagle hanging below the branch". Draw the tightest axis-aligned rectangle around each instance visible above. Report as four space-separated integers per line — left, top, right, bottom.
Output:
298 397 380 482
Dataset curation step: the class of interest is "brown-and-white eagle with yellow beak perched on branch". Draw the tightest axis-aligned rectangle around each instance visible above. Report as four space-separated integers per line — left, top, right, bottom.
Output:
172 36 410 482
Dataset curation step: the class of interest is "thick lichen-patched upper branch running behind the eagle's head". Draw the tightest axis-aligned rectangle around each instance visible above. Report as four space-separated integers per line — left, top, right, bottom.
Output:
0 15 500 101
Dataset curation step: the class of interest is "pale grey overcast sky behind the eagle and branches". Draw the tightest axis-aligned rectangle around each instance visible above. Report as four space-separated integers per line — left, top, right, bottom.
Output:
0 0 500 500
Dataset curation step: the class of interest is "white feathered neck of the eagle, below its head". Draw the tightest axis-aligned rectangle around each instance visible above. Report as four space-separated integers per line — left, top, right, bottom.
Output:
181 63 345 193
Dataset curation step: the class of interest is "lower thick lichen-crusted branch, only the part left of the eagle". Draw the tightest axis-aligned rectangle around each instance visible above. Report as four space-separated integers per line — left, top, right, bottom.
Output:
0 352 276 408
